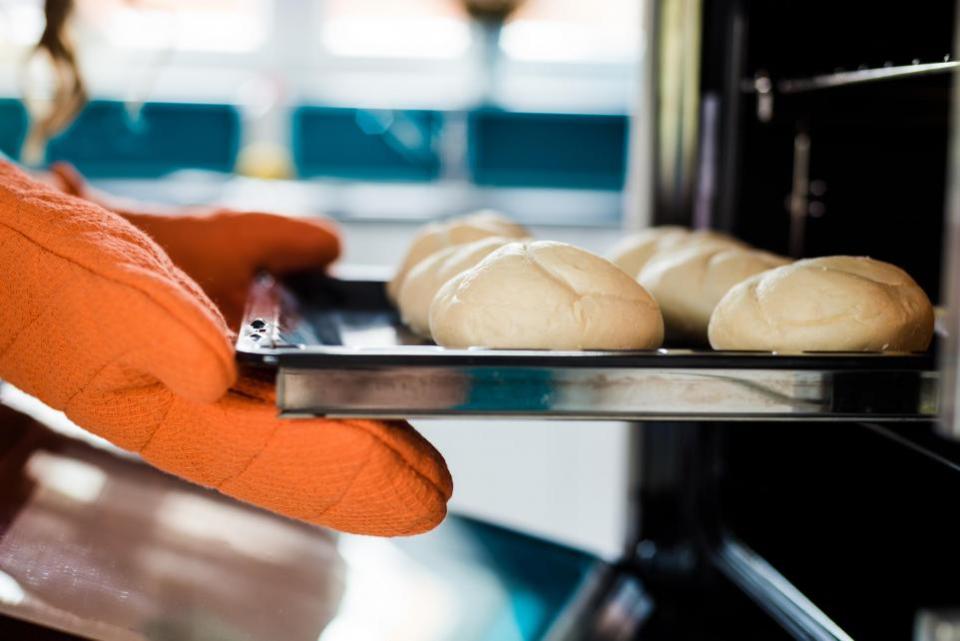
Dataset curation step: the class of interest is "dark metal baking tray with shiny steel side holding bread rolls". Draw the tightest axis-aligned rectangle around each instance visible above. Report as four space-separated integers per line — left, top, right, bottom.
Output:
236 273 939 421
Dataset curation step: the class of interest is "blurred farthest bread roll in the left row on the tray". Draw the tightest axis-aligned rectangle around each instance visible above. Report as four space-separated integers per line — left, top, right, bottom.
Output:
387 210 530 302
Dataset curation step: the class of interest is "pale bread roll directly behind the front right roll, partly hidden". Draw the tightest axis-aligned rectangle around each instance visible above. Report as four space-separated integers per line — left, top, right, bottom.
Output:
637 242 790 343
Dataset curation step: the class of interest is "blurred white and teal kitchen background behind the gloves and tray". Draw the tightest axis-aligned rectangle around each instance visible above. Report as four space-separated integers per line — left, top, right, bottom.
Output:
0 0 644 555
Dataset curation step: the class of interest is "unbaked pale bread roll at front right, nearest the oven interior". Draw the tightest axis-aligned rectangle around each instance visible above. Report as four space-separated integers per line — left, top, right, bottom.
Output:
710 256 933 352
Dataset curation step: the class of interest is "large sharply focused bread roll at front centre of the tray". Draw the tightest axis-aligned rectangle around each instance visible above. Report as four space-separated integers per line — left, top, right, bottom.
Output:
430 241 663 349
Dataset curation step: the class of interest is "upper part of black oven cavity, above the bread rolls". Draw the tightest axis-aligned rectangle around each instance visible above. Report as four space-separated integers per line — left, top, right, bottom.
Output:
680 0 955 299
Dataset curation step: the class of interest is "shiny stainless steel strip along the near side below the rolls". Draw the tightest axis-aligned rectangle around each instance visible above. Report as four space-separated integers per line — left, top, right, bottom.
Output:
277 367 938 421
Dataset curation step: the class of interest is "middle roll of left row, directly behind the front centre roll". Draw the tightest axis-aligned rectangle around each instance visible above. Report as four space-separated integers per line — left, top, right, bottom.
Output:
397 236 512 337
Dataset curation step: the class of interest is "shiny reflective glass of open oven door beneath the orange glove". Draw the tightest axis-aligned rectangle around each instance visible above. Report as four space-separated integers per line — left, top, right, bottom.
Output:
0 407 598 641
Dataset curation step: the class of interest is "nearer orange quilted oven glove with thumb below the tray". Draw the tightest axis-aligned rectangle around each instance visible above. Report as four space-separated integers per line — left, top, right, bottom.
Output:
0 162 452 536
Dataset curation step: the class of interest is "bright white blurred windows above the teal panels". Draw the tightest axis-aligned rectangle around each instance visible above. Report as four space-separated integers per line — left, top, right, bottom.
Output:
0 0 643 119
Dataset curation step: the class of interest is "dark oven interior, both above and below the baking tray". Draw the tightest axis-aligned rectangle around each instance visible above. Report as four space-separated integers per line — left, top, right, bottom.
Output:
631 0 960 640
